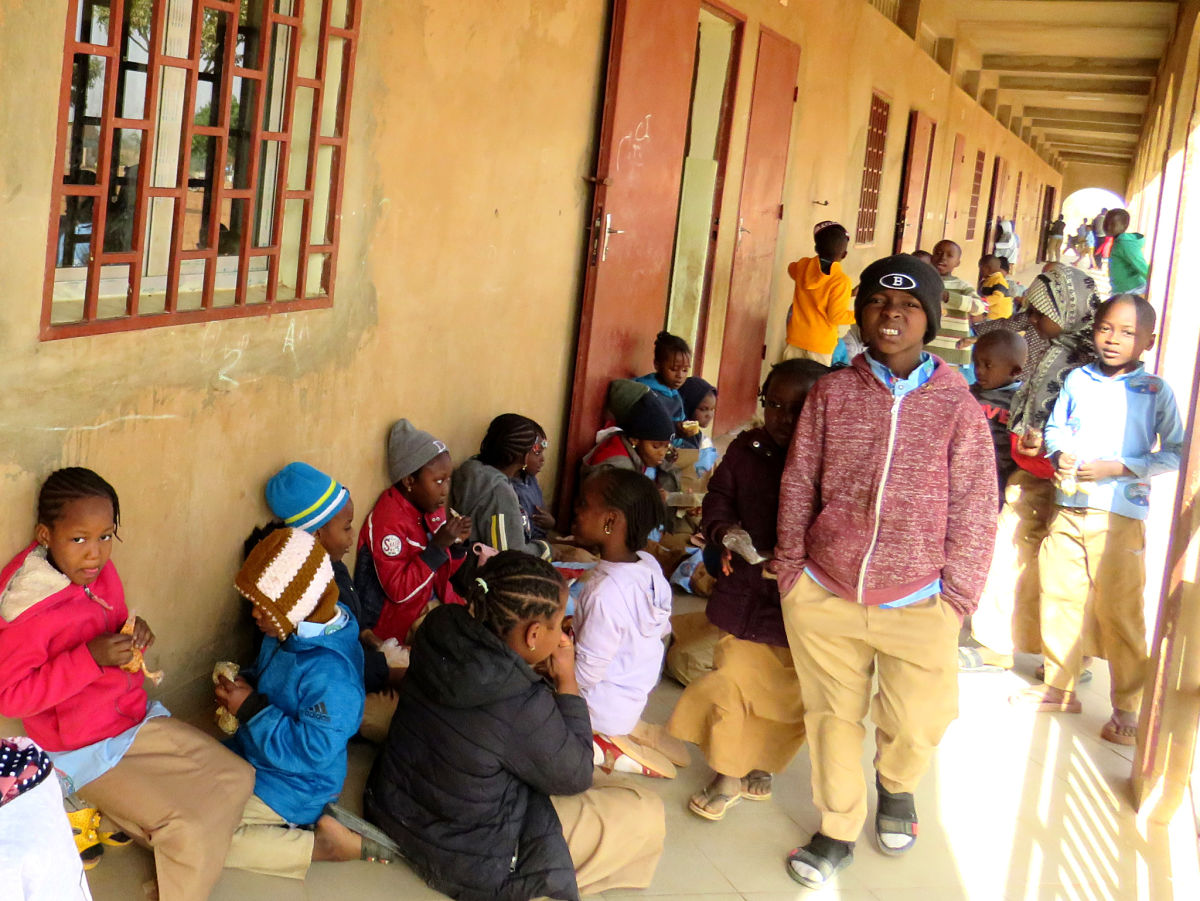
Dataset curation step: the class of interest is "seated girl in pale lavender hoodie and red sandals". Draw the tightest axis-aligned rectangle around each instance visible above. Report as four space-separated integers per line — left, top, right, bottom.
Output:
571 469 690 779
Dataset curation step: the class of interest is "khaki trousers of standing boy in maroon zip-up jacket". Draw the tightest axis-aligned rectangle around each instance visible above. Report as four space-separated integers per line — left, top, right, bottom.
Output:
782 575 960 841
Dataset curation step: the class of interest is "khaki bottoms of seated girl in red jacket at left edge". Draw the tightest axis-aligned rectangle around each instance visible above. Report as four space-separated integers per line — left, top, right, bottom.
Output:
79 716 254 901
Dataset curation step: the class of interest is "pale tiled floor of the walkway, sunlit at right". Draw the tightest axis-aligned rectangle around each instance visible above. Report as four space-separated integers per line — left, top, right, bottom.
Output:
90 607 1200 901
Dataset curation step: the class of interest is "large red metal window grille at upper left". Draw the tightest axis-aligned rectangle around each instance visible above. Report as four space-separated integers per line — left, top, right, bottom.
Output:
41 0 361 340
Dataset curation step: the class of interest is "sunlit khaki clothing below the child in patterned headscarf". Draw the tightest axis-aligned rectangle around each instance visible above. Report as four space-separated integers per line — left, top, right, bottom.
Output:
971 469 1055 656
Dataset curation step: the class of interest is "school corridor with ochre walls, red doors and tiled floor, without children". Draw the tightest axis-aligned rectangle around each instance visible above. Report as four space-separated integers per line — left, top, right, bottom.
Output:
0 0 1200 901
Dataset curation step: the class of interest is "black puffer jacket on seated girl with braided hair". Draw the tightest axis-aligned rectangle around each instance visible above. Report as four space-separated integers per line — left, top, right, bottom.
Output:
364 605 592 901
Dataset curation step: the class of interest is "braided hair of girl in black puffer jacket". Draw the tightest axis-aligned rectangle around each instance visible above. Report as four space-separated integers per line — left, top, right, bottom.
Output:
467 549 566 638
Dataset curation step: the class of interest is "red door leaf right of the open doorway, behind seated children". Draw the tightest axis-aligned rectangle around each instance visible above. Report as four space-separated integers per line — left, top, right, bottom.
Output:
714 29 800 434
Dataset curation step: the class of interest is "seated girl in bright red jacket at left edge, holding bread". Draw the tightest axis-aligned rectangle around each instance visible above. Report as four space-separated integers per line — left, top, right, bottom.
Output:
0 467 254 901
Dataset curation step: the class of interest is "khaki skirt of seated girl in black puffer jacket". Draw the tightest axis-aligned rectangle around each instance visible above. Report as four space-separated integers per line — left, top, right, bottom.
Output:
550 770 667 895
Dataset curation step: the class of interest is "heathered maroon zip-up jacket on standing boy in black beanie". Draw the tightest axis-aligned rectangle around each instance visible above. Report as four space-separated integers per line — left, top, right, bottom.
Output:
775 354 996 614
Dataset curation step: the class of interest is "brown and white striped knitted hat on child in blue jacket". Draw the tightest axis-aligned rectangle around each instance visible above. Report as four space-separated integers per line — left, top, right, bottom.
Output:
233 529 337 637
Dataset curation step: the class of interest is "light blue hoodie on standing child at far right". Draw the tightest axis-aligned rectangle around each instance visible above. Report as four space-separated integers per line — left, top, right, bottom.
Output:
1045 364 1183 519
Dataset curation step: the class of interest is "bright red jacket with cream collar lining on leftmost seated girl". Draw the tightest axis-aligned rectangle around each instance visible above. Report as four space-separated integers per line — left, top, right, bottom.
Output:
0 545 146 751
